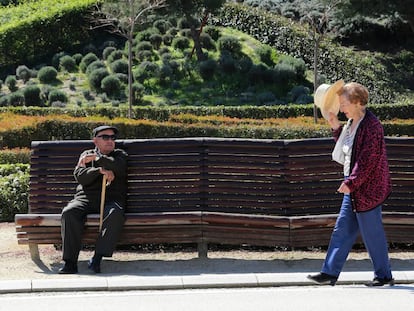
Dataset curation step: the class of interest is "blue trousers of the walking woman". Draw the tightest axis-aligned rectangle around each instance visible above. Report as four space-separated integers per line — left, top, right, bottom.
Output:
321 194 392 278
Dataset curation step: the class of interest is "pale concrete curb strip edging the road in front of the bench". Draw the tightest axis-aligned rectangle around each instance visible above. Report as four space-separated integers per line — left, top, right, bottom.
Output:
0 271 414 294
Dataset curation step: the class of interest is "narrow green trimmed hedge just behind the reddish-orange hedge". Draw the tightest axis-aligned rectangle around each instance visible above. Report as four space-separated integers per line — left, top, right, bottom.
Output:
0 103 414 122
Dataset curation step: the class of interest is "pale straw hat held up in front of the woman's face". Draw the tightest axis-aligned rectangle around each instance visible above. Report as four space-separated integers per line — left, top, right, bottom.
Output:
314 80 345 120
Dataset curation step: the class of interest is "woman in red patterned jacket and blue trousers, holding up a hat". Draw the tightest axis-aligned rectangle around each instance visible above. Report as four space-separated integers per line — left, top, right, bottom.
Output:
308 80 394 286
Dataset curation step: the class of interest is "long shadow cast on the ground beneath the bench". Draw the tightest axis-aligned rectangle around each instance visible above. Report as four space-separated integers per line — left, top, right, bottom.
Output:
79 258 414 276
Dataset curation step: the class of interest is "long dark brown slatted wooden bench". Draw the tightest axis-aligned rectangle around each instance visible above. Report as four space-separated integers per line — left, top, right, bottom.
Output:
15 138 414 259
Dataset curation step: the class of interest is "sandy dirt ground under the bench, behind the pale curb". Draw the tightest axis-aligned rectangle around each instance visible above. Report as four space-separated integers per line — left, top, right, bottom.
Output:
0 222 414 280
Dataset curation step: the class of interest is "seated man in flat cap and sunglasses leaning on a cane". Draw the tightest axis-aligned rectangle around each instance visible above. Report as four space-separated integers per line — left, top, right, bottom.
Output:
59 125 127 274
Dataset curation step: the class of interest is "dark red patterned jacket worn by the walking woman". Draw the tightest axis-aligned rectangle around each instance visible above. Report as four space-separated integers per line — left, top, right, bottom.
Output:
333 110 391 212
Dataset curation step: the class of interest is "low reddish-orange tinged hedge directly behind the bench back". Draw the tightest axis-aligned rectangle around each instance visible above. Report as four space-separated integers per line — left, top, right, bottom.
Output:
0 117 414 148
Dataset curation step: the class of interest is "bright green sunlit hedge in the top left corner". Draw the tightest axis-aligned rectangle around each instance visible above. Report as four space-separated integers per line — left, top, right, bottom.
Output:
0 0 99 67
